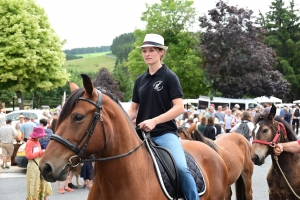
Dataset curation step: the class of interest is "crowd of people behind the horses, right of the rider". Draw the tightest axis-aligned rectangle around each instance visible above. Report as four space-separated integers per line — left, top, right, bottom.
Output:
176 103 300 142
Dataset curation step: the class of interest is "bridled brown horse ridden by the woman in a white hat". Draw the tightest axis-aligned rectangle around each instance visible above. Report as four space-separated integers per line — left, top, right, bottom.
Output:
40 75 228 200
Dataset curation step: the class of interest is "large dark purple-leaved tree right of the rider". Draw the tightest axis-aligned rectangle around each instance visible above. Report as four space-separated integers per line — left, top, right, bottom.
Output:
199 1 289 98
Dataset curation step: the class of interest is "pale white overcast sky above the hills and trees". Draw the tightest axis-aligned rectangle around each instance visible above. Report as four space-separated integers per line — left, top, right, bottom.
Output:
36 0 292 49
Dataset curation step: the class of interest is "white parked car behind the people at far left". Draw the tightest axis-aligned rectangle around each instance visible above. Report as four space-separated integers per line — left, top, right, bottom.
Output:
6 110 43 124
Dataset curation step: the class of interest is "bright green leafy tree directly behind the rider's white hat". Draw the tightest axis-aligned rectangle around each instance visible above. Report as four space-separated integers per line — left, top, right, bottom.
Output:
128 0 208 98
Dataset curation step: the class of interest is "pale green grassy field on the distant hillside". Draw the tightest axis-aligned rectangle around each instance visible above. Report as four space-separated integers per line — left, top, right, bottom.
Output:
63 52 116 72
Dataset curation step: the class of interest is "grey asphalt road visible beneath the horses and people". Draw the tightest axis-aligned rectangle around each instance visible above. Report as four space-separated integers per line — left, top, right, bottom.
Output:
0 156 271 200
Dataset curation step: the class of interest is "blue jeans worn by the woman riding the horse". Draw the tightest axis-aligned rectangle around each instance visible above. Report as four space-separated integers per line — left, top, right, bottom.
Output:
151 133 199 200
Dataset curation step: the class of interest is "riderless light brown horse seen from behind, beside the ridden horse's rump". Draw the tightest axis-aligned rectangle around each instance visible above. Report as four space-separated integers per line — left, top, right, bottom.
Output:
178 127 254 200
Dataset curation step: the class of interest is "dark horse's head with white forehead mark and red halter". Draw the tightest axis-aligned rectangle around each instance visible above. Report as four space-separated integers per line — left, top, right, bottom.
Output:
251 105 296 165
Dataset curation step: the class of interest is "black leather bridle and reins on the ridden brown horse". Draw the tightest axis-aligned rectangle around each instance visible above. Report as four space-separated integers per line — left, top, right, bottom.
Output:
50 89 146 167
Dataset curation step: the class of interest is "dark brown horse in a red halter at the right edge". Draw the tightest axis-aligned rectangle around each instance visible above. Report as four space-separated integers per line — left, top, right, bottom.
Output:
251 105 300 200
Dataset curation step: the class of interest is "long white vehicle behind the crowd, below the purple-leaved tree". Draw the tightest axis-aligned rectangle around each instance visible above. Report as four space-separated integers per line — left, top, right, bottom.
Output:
198 96 263 110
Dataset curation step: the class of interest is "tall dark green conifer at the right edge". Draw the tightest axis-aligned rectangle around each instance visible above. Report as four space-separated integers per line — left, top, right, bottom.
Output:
258 0 300 102
